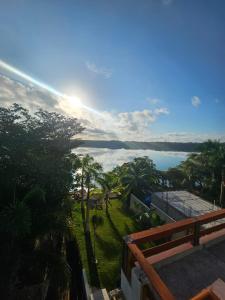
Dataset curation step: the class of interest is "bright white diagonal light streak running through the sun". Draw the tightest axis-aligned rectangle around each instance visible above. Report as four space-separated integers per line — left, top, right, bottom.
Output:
0 60 102 116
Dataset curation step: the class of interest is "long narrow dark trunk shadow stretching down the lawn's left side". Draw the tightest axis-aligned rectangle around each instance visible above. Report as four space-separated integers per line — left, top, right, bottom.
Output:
85 232 101 288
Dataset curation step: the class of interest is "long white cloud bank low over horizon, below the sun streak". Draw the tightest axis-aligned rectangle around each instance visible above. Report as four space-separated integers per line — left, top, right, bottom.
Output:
0 75 225 142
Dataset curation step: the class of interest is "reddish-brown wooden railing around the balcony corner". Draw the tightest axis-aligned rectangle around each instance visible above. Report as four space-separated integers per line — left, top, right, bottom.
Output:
123 209 225 300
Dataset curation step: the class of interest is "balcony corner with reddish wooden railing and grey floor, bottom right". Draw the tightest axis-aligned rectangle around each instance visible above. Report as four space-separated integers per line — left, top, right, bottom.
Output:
121 209 225 300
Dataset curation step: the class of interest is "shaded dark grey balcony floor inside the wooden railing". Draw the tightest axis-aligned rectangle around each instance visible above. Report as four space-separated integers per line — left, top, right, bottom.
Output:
157 241 225 300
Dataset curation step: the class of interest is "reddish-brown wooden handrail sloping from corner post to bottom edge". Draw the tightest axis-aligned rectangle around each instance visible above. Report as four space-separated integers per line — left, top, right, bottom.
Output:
127 243 175 300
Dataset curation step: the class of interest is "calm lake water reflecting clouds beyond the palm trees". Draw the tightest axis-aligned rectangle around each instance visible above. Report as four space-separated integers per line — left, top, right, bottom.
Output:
73 147 188 172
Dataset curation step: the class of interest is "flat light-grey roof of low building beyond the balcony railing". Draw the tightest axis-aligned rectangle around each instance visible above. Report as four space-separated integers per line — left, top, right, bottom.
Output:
153 191 220 217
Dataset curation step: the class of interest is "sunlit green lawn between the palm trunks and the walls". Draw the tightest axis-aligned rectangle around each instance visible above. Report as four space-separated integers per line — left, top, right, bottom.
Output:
74 200 140 290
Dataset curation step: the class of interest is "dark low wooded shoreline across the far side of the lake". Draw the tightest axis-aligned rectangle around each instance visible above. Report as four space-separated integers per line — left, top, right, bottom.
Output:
71 140 202 152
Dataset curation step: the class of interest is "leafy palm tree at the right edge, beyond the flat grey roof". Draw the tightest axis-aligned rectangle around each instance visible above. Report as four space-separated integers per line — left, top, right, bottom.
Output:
166 140 225 202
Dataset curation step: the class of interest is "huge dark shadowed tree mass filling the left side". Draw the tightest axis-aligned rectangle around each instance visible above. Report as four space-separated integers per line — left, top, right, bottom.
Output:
0 104 83 299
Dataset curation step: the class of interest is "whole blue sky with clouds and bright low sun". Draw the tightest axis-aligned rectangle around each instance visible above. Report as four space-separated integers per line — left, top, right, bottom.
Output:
0 0 225 142
